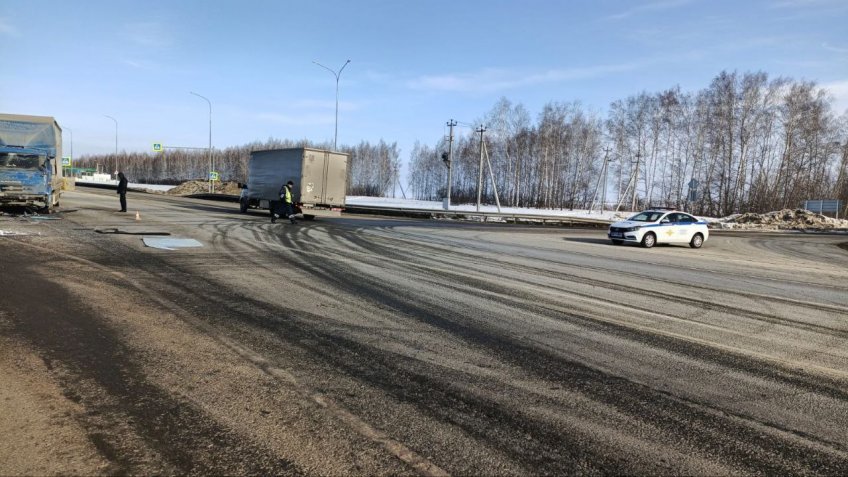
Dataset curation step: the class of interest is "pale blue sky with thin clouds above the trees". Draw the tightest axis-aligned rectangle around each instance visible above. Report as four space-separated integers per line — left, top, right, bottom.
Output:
0 0 848 167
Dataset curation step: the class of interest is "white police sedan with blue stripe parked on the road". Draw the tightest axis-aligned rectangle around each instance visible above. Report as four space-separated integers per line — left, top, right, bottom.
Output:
607 209 710 248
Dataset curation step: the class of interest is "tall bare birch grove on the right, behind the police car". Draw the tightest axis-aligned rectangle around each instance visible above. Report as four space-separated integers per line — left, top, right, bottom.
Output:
409 71 848 216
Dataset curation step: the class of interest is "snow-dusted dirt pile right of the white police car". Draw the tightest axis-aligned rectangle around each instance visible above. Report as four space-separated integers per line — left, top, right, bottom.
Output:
718 209 848 230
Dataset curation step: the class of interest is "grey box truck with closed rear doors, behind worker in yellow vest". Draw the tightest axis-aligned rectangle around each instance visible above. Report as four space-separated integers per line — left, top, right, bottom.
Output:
239 147 350 220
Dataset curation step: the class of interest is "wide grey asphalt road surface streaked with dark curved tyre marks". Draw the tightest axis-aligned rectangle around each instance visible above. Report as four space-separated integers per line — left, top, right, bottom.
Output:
0 190 848 475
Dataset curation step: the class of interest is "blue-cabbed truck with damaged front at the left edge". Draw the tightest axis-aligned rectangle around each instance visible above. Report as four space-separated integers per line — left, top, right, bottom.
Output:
0 114 63 213
